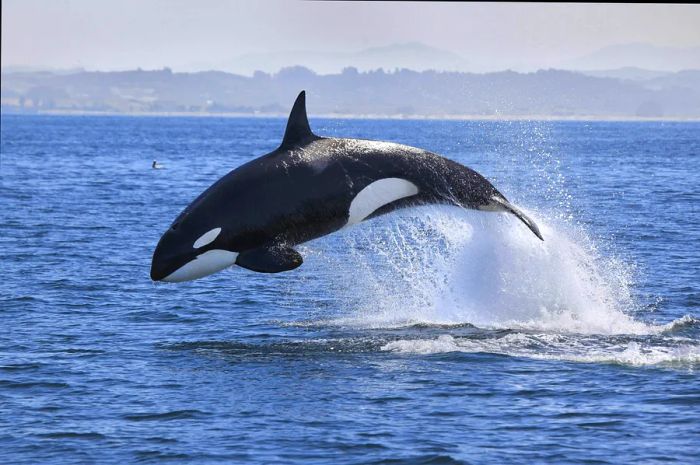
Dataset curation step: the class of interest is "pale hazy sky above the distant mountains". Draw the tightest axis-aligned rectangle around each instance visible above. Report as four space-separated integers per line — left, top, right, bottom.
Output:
2 0 700 70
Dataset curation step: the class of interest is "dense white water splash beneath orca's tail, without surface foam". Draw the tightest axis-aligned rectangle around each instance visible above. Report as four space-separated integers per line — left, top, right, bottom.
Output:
308 207 662 334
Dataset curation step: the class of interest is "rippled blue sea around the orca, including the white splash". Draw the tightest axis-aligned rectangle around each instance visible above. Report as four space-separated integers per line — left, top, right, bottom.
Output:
0 115 700 464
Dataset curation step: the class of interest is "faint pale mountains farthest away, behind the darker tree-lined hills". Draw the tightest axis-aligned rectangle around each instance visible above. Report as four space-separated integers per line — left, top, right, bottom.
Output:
186 42 700 75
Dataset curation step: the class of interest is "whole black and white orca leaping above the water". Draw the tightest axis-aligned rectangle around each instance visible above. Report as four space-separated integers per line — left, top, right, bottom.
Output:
151 91 543 282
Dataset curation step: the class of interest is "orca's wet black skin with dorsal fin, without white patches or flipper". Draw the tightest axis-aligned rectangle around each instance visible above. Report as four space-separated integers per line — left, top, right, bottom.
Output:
151 93 540 280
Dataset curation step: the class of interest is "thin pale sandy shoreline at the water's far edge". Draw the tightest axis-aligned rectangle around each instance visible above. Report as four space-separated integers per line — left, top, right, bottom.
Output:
2 110 700 123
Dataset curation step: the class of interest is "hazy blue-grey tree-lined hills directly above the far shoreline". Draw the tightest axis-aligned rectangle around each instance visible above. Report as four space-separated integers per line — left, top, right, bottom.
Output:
1 66 700 118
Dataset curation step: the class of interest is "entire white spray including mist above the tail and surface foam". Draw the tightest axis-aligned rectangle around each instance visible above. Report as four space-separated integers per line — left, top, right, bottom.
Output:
286 124 700 364
